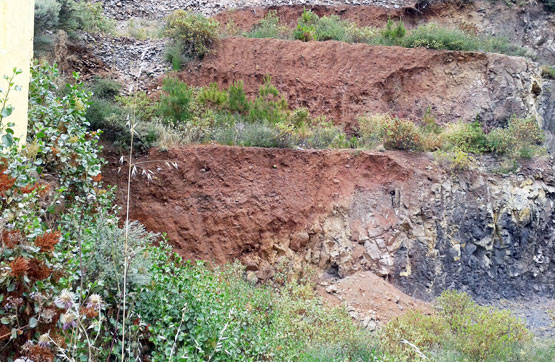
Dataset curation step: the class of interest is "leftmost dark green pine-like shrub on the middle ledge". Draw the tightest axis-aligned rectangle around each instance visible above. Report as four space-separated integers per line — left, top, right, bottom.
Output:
160 77 193 124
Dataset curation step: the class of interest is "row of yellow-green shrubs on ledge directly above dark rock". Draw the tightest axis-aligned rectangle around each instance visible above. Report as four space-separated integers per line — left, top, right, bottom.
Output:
358 110 545 170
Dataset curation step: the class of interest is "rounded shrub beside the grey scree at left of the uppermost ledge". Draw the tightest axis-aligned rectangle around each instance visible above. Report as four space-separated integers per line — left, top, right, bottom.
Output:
165 10 220 59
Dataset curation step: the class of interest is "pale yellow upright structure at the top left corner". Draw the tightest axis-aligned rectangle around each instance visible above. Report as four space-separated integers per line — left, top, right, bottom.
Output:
0 0 35 142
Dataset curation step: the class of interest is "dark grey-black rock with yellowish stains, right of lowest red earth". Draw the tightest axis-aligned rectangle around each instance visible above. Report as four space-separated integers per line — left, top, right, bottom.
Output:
394 173 555 297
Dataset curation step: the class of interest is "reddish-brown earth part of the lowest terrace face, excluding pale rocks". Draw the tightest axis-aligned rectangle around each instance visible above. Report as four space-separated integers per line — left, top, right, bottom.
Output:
104 146 439 262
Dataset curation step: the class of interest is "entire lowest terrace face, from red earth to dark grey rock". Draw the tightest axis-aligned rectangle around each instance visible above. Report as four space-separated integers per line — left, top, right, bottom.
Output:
105 146 555 299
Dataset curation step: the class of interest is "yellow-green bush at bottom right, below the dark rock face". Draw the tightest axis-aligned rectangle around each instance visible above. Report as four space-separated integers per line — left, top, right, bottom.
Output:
380 291 532 361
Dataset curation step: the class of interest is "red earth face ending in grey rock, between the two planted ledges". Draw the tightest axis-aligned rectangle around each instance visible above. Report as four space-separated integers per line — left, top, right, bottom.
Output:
179 38 536 129
